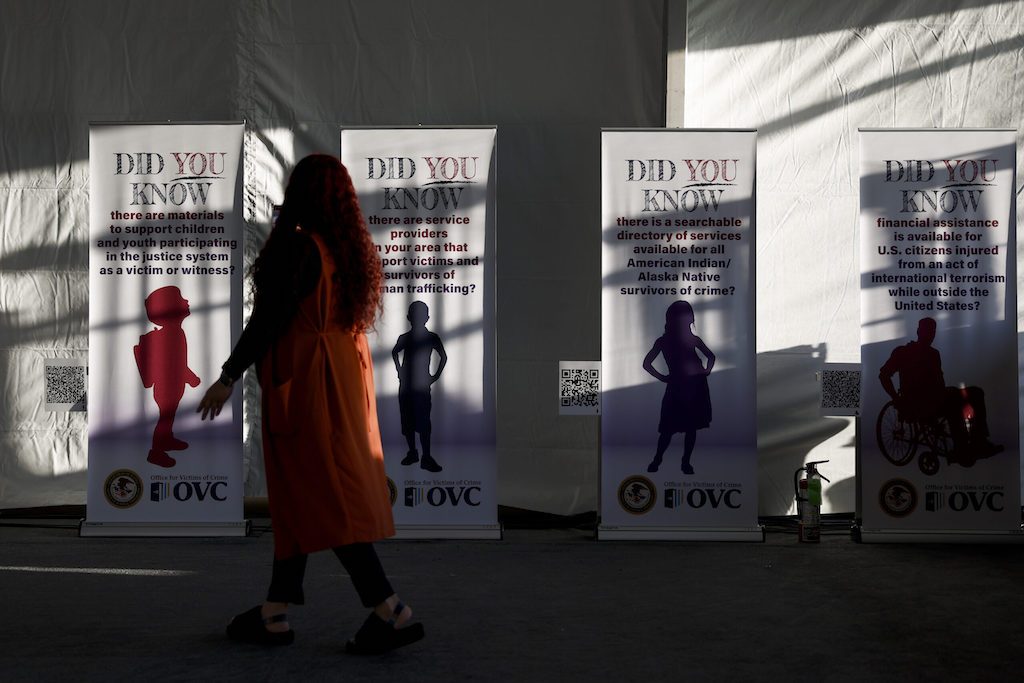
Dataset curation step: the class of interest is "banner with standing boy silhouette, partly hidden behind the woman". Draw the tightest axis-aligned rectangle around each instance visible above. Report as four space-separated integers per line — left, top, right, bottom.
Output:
341 127 501 539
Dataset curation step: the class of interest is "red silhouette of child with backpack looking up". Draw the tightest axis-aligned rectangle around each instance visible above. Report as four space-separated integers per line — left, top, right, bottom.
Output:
135 287 200 467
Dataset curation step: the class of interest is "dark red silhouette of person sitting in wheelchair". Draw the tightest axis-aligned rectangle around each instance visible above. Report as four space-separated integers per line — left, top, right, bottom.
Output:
877 317 1002 474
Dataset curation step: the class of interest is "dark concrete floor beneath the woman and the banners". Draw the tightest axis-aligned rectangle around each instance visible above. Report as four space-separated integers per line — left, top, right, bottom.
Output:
0 519 1024 683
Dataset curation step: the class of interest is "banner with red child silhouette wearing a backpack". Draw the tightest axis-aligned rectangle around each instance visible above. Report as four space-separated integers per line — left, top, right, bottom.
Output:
82 123 245 536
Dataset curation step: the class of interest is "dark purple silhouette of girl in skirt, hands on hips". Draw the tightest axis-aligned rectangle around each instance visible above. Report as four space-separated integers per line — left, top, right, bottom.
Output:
643 301 715 474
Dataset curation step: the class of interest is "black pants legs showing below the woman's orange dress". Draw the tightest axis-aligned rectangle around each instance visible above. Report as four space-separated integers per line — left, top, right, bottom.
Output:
266 543 394 607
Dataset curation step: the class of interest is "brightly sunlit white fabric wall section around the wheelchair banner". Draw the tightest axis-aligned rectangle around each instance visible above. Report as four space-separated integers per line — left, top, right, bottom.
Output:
670 0 1024 514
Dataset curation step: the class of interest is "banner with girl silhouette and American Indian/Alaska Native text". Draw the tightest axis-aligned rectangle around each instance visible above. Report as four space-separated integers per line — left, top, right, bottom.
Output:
598 130 764 541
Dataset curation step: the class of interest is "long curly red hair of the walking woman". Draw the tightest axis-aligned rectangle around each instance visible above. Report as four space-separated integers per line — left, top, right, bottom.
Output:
252 155 383 332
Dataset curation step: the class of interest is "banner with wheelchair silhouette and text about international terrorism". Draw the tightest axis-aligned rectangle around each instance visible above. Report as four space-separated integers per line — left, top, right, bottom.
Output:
859 129 1024 541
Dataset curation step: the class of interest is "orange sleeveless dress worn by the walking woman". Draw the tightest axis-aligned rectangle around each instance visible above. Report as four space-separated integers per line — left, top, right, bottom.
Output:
260 234 394 559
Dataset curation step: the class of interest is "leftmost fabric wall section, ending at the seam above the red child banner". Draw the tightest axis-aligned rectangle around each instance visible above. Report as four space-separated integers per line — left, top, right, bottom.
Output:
0 0 242 508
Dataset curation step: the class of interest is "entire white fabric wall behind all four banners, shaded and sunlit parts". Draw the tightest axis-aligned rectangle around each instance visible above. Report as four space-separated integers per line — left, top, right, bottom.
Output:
0 0 1024 515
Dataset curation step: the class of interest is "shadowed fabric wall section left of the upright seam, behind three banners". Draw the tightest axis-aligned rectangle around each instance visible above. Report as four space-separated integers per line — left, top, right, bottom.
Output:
0 0 665 513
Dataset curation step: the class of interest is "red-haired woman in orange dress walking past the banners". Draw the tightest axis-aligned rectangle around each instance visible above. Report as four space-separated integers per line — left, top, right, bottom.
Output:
198 155 423 654
